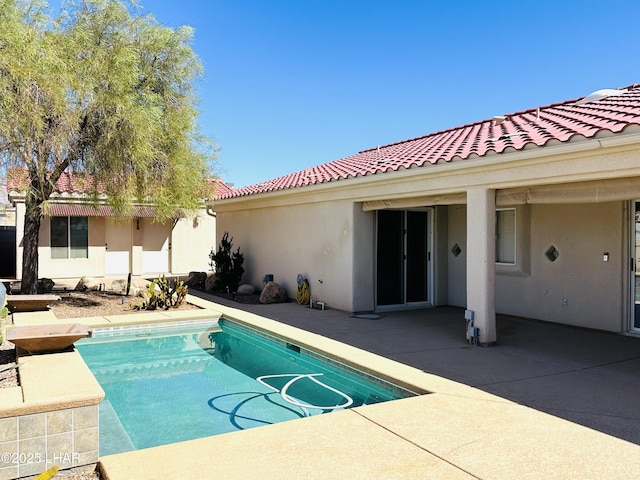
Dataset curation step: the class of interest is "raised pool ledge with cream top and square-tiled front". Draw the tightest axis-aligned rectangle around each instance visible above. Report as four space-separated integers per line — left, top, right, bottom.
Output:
0 349 104 480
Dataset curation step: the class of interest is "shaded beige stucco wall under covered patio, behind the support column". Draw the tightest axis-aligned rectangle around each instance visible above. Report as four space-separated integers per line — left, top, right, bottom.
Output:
448 202 629 332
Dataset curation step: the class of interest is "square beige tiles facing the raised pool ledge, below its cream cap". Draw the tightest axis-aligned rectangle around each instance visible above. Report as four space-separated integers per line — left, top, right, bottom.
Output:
0 405 100 480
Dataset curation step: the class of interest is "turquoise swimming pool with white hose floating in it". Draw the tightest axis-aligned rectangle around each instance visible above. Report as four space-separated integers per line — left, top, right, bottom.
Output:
76 319 415 456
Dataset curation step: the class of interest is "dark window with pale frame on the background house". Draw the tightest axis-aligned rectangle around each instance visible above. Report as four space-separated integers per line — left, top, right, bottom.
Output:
51 217 89 259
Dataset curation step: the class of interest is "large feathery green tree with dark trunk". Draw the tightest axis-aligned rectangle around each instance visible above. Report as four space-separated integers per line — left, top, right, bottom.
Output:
0 0 213 293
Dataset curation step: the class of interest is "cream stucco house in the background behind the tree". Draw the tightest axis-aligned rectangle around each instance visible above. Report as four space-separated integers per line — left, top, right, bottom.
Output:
7 171 228 280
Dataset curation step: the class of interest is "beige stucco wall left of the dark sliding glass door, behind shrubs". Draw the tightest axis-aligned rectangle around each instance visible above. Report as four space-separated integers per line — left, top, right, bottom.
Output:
216 201 362 311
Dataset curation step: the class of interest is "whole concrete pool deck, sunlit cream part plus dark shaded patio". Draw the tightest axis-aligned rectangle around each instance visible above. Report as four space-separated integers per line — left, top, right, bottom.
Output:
6 295 640 480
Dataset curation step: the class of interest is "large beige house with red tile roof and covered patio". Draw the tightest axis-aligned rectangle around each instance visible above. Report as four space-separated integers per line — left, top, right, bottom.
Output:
214 84 640 344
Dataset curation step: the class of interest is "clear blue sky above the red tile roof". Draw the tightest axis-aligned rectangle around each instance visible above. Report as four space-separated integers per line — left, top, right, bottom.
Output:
110 0 640 187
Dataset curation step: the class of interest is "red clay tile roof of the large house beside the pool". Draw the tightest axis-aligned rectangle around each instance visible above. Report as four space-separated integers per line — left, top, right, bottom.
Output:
217 84 640 200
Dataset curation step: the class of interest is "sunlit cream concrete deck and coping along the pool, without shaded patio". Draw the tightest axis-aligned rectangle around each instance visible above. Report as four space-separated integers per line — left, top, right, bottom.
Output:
8 299 640 480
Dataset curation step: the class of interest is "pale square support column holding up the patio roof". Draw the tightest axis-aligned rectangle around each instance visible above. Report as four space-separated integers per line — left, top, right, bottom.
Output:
467 188 496 345
